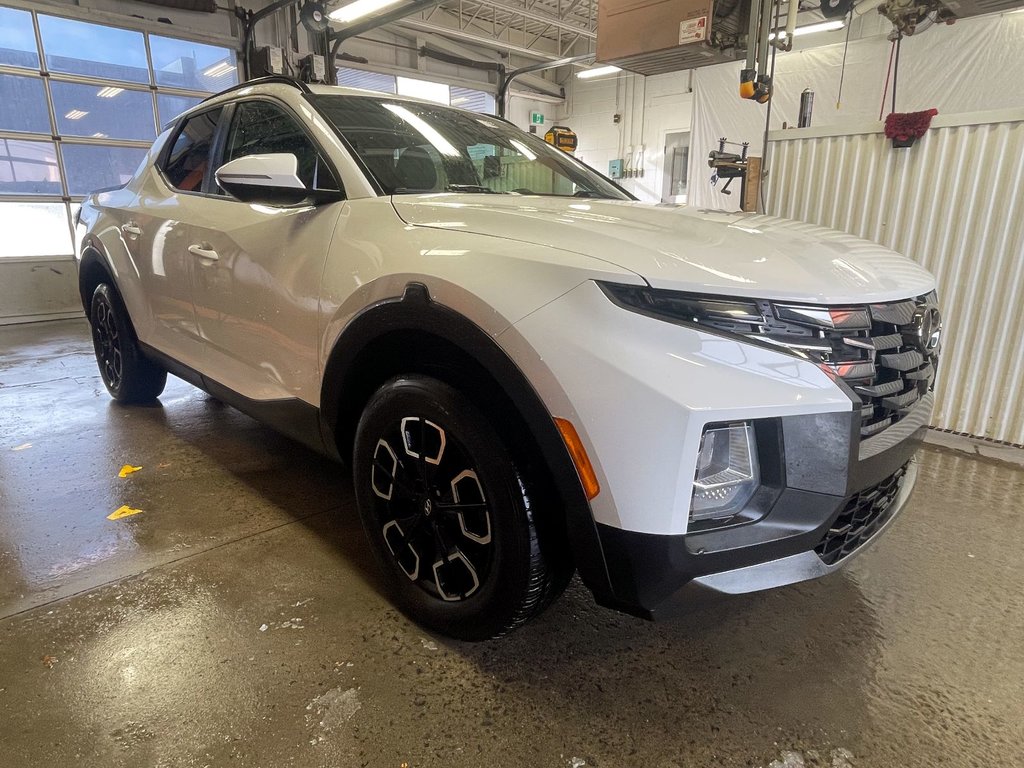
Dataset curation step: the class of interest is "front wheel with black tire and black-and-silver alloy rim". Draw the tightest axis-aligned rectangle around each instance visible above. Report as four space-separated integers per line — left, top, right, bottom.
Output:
352 376 566 640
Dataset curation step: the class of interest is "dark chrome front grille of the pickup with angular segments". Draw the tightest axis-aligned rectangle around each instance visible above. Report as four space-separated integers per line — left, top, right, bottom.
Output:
692 292 941 439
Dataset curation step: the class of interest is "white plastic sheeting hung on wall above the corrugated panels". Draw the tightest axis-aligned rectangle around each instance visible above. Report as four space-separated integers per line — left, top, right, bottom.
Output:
690 12 1024 210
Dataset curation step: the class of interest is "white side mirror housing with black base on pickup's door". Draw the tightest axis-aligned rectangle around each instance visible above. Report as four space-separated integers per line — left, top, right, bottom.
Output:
214 153 344 205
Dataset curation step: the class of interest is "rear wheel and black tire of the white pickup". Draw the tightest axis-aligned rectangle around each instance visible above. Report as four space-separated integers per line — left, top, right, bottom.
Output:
89 283 167 404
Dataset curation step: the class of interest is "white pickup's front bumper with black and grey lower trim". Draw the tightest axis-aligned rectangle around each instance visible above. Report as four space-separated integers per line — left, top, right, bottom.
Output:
502 284 932 617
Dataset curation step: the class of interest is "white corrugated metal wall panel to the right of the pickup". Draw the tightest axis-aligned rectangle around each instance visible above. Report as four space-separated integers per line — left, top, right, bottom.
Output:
767 110 1024 444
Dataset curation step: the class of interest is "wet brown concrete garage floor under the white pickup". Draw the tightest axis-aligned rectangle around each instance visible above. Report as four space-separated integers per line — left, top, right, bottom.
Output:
0 321 1024 768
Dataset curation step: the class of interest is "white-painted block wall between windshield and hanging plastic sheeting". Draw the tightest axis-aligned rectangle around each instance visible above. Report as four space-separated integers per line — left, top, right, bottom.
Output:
559 72 693 202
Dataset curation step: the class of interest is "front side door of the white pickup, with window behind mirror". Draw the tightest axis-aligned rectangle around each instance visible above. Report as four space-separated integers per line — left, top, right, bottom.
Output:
188 99 346 406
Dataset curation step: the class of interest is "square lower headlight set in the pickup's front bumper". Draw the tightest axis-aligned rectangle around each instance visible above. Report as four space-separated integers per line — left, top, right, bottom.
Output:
690 422 761 522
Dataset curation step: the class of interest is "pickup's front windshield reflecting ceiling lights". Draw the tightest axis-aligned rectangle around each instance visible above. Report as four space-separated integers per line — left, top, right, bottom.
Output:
311 95 630 200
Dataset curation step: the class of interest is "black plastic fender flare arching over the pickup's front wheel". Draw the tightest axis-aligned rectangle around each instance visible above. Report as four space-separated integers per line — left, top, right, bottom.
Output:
321 283 613 600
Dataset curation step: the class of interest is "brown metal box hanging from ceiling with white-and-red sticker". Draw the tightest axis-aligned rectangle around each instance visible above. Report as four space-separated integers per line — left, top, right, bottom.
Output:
597 0 751 75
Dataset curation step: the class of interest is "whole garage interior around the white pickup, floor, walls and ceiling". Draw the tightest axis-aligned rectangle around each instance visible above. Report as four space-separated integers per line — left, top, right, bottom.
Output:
0 0 1024 768
